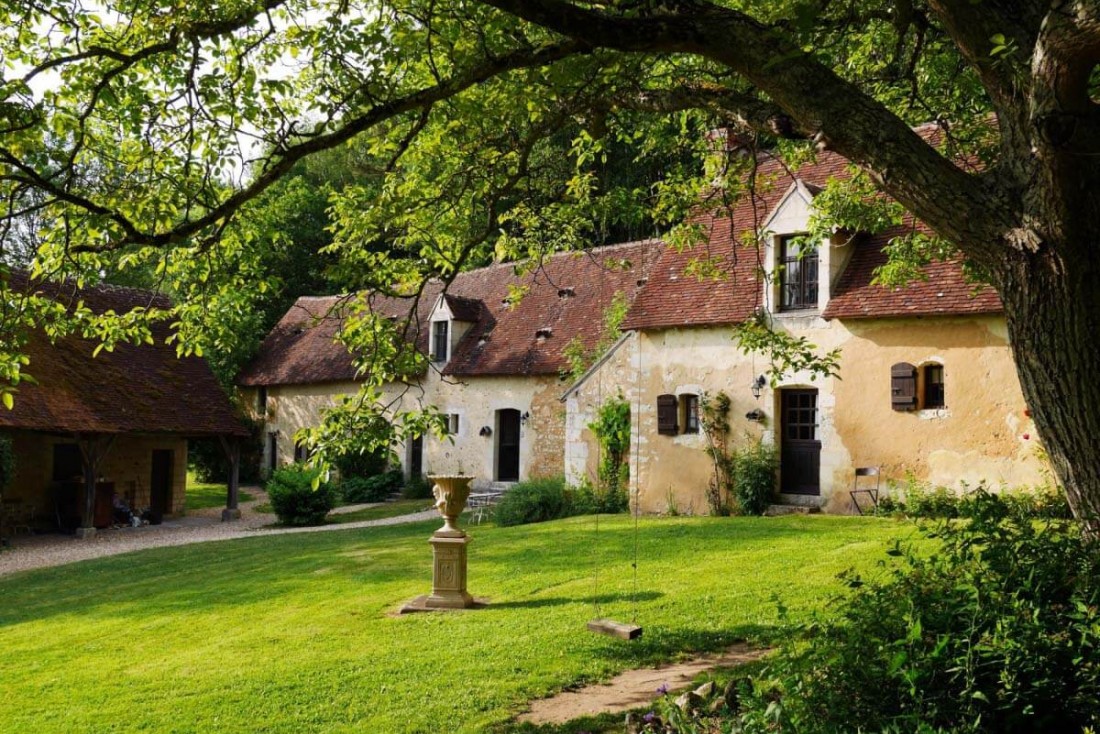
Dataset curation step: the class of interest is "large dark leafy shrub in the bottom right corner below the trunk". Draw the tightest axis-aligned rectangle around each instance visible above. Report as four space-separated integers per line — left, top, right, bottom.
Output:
738 489 1100 732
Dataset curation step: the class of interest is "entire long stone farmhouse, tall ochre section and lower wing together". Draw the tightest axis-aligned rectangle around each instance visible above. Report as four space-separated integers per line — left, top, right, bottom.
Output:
240 143 1044 513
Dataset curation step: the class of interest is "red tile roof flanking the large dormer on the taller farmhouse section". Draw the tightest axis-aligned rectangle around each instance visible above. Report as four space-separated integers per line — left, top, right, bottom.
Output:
624 145 1001 329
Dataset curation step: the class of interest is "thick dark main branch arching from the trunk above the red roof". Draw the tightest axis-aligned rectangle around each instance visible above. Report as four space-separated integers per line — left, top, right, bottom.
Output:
483 0 1015 261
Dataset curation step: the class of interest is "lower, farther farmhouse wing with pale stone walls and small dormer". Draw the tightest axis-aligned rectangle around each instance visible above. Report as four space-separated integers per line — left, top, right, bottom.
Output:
239 241 661 486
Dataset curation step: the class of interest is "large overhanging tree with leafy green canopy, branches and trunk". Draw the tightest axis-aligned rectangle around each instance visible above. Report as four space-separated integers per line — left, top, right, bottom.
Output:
0 0 1100 528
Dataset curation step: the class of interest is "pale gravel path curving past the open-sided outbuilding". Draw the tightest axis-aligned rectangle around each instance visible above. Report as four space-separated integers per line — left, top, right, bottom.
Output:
0 486 439 577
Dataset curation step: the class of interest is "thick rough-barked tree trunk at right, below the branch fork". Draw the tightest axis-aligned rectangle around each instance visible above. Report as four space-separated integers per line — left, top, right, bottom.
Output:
999 247 1100 537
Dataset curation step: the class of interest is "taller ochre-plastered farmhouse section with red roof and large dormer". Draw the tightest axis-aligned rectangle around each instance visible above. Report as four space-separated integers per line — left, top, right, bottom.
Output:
563 148 1044 513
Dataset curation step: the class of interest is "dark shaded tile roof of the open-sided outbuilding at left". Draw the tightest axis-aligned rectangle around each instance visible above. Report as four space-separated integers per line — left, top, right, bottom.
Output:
0 273 248 437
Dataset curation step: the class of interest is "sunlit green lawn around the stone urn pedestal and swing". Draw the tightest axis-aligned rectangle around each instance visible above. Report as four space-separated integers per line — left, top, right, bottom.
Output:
0 516 911 733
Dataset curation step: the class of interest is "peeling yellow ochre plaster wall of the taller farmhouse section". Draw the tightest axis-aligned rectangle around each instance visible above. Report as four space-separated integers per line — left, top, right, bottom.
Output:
564 314 1045 513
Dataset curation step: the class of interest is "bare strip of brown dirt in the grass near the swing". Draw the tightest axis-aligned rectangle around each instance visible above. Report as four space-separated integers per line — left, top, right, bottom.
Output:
519 644 768 724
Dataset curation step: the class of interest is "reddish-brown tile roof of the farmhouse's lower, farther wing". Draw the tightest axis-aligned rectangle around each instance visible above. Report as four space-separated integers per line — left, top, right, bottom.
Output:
238 240 663 385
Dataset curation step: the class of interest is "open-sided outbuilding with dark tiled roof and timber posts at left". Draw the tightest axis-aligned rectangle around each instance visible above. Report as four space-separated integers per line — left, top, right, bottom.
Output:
0 272 249 536
